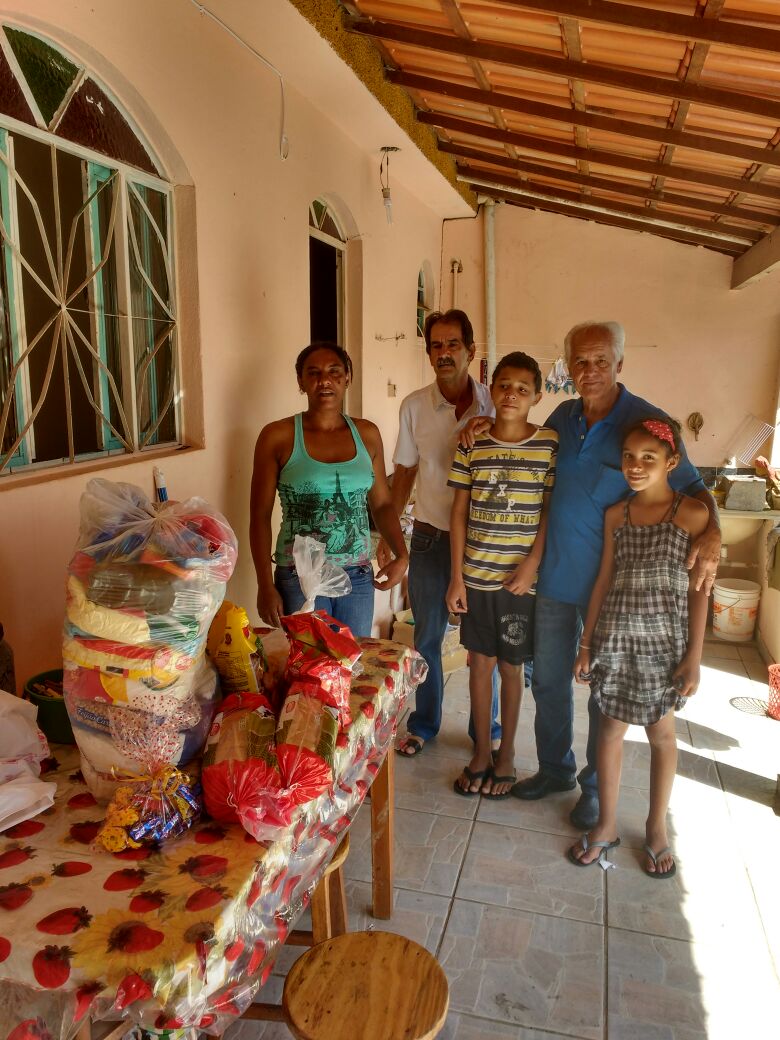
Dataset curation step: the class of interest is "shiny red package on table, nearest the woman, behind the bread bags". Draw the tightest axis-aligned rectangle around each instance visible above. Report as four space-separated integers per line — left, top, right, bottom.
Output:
282 610 361 729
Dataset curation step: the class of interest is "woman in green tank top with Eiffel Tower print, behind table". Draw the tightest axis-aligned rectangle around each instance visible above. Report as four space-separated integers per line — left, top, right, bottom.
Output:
250 343 409 635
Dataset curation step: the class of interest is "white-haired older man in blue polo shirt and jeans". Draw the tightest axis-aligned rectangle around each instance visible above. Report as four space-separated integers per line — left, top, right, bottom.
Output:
512 321 721 830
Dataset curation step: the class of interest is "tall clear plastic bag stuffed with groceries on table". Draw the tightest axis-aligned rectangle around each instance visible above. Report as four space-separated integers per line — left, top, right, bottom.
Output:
62 479 237 800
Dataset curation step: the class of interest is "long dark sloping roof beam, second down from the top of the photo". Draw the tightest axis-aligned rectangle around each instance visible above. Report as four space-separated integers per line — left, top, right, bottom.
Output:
344 16 780 123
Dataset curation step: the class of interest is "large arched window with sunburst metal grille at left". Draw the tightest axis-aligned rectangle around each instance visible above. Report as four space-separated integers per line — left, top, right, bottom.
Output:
0 25 179 477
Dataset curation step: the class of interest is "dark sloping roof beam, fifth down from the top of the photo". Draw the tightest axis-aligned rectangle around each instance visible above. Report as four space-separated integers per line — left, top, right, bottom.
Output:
439 141 780 225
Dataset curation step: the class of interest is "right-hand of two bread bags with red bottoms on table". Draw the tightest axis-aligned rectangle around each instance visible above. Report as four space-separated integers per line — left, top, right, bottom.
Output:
277 678 339 805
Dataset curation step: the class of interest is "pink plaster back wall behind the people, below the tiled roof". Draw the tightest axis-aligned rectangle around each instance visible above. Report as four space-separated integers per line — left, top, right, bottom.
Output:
441 206 780 660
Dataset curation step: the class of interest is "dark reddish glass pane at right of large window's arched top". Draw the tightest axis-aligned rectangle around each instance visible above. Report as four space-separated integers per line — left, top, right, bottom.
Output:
56 79 157 174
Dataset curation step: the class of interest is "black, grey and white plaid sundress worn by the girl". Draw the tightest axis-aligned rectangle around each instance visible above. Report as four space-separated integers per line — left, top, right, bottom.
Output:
591 494 691 726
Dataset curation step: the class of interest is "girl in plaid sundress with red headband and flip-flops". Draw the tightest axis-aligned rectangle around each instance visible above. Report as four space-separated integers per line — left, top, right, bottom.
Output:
569 417 709 879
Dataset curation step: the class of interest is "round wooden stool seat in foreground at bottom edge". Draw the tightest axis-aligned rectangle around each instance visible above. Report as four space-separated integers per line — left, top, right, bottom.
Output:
282 932 449 1040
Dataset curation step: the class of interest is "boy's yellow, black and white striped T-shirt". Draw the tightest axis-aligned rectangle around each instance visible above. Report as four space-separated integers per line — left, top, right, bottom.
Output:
447 426 557 592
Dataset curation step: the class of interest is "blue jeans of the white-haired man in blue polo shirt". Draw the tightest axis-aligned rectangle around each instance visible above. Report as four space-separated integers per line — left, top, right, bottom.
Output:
531 595 600 794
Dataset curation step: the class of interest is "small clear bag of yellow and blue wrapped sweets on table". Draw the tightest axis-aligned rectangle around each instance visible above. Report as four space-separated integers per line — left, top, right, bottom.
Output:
95 765 202 852
